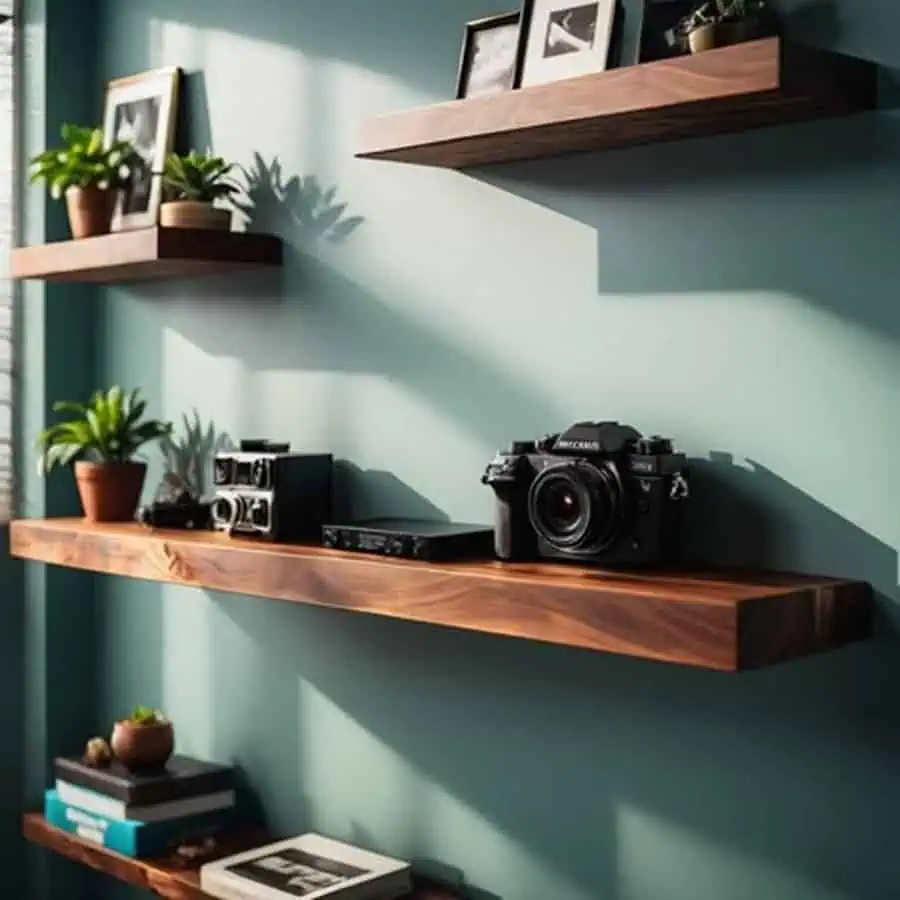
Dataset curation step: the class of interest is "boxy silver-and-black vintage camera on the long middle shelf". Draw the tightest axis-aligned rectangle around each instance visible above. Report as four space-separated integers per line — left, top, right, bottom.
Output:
212 441 332 541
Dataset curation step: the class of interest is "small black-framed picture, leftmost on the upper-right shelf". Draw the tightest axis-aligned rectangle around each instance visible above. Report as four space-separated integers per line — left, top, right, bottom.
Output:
456 10 521 100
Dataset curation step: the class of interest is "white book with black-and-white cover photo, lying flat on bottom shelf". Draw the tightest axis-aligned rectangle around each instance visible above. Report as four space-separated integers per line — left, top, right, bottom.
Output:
200 834 412 900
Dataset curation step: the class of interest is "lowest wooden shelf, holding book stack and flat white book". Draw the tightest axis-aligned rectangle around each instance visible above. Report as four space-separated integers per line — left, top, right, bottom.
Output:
22 813 459 900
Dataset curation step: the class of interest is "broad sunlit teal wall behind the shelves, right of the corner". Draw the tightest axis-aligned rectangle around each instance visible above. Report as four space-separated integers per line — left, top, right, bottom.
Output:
84 0 900 900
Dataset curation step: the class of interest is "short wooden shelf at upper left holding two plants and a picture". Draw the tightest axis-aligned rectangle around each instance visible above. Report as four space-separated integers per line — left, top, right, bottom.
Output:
11 228 283 284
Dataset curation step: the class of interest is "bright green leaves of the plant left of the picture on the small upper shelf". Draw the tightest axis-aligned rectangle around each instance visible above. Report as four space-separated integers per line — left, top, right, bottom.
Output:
31 124 137 200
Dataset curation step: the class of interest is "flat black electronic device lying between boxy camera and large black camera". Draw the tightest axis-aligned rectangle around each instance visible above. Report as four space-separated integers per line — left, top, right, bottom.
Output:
322 519 494 562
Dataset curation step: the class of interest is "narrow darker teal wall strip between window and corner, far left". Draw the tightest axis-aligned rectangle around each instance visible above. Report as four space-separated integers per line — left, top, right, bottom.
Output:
16 0 99 898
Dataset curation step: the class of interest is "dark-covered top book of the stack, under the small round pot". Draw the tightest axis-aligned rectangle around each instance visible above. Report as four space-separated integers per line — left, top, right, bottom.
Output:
55 756 235 806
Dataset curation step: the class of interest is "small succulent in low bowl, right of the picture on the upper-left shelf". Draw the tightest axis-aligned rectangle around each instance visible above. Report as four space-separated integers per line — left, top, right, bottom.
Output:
159 150 240 231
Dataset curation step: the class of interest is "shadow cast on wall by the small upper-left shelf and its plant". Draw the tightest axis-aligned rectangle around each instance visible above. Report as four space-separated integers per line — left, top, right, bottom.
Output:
157 156 557 458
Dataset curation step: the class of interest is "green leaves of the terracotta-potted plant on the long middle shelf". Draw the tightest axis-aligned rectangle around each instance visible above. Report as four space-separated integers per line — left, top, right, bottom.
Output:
37 386 172 474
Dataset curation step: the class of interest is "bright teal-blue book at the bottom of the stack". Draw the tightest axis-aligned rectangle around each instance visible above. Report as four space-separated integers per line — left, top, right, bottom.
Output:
44 790 238 859
